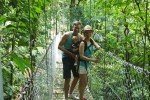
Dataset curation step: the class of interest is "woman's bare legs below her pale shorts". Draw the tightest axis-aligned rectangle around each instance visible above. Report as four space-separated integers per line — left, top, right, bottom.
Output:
79 74 87 100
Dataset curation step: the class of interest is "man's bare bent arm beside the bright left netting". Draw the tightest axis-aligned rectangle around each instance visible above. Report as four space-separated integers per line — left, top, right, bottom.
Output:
58 33 75 58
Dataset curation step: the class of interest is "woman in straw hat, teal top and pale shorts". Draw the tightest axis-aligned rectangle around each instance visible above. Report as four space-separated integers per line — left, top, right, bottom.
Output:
79 25 100 100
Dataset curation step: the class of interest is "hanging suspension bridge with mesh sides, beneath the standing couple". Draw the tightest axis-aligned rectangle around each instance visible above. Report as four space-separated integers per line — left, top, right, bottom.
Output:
12 31 150 100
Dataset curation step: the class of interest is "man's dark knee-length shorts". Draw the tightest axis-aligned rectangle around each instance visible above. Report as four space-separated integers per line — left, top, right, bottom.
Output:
62 57 79 79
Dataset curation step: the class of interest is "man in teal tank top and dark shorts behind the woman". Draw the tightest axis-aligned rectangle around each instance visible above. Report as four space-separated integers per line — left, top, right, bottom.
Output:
58 21 83 100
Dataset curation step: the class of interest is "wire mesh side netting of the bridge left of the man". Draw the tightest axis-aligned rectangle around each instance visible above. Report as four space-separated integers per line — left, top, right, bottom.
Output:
18 34 60 100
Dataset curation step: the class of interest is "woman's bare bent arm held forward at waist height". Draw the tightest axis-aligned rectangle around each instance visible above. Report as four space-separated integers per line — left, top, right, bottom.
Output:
79 42 97 62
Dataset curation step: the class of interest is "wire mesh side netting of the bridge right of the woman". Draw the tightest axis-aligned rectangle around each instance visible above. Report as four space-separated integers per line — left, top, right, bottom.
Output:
89 52 149 100
